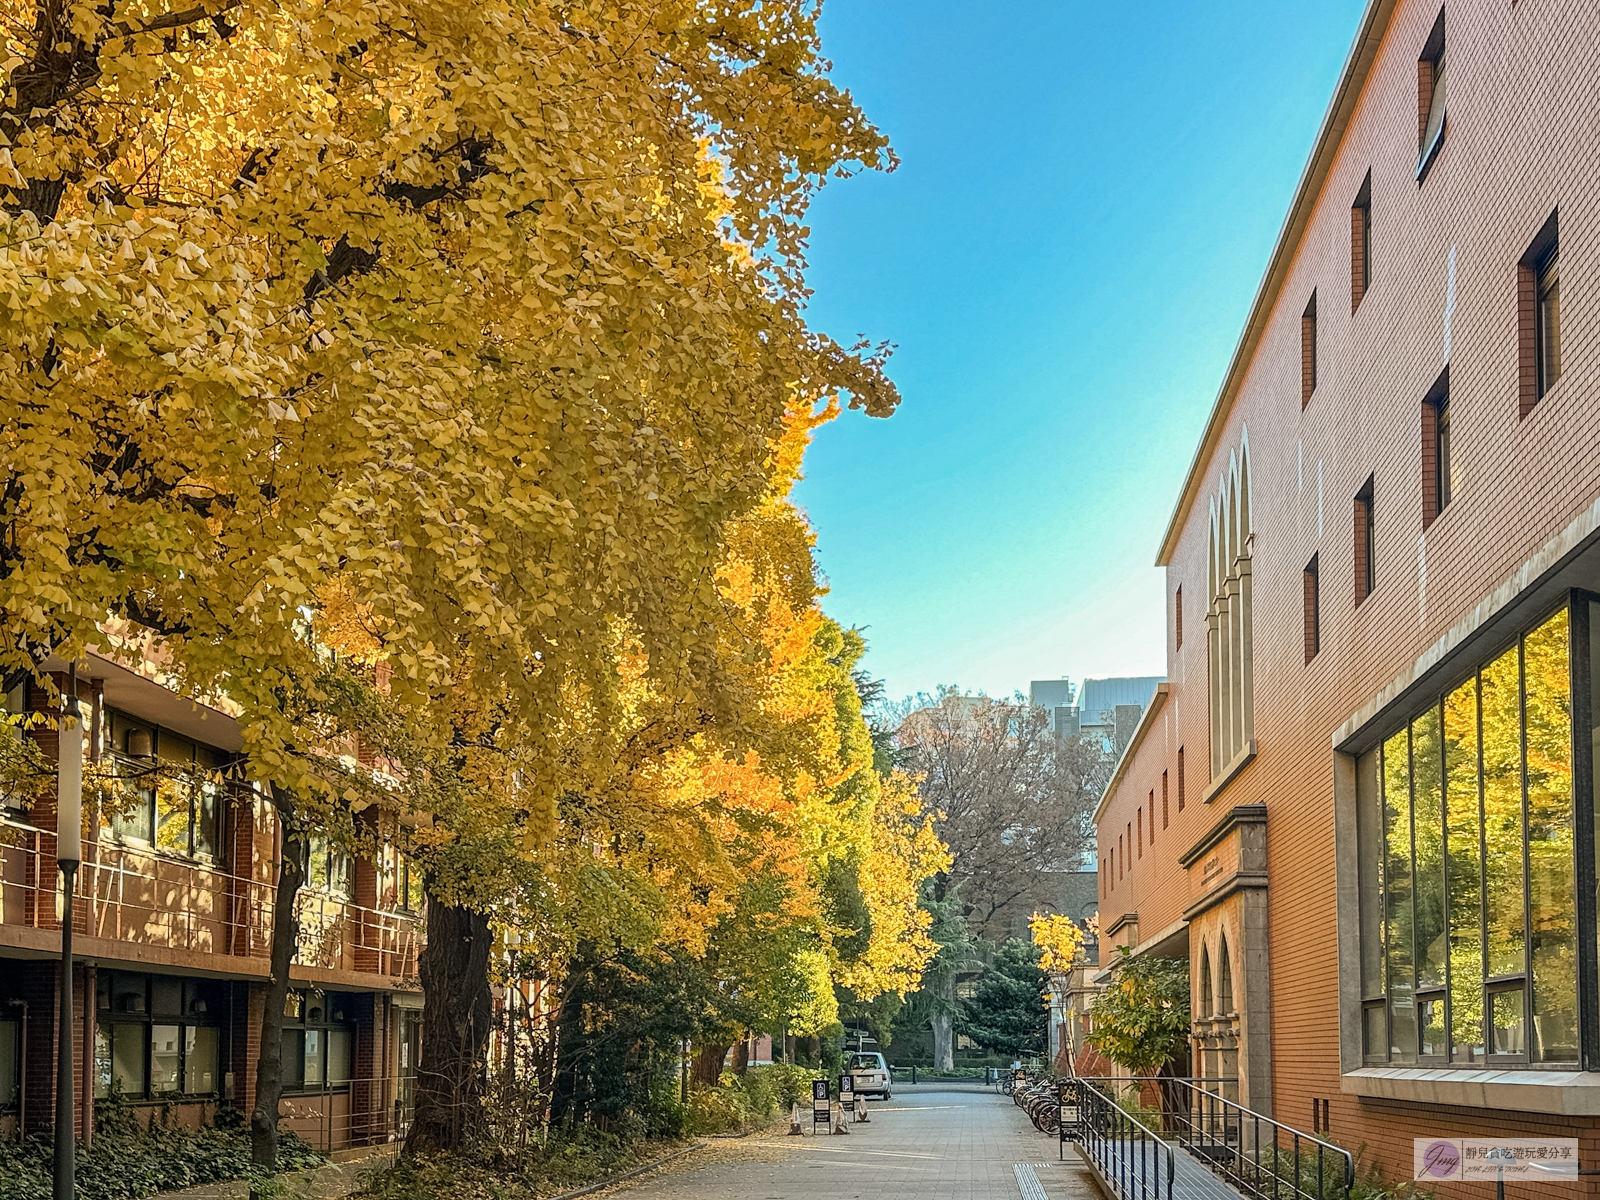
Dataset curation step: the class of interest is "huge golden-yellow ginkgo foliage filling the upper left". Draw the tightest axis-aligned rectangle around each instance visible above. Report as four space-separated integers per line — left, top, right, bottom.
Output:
0 0 898 1184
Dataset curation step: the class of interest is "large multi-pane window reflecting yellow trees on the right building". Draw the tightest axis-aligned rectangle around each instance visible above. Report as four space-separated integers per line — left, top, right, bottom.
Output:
1357 608 1579 1064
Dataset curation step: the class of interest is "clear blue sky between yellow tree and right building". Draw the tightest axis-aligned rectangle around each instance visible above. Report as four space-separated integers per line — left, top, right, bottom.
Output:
797 0 1362 696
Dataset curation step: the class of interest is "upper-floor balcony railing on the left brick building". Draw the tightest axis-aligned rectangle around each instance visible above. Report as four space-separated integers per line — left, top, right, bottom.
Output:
0 821 422 978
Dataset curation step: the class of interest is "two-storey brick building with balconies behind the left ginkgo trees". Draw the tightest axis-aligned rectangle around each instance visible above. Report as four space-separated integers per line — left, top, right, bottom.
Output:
0 654 424 1150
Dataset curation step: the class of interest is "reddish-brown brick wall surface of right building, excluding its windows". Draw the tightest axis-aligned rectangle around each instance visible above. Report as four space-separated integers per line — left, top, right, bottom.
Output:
1099 0 1600 1195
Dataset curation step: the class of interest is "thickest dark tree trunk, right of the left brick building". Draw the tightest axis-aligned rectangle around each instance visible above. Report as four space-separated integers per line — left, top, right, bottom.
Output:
405 894 494 1155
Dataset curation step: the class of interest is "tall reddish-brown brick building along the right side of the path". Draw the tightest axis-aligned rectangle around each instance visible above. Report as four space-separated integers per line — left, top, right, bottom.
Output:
1096 0 1600 1194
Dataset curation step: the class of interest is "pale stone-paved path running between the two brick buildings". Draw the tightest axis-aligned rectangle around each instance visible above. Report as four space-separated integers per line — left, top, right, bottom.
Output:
598 1083 1102 1200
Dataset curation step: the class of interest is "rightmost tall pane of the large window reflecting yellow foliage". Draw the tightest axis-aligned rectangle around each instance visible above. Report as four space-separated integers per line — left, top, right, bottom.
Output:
1523 608 1578 1062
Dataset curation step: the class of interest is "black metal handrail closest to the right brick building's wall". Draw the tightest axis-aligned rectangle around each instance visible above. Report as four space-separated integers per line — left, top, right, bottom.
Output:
1128 1077 1355 1200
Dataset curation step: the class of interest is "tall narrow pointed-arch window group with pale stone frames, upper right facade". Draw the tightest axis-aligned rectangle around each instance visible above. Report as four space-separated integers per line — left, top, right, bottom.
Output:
1205 430 1256 779
